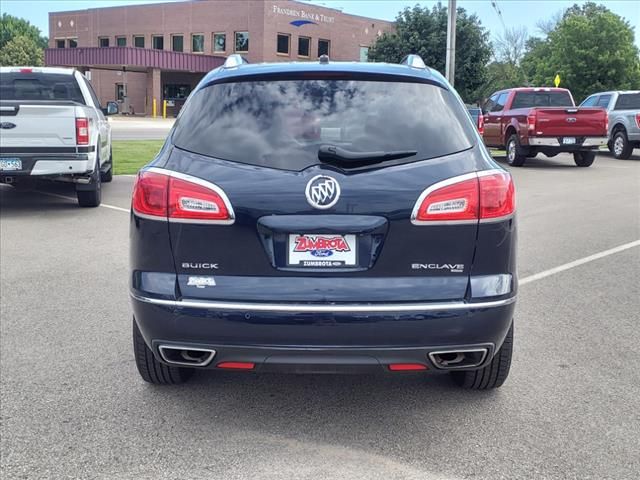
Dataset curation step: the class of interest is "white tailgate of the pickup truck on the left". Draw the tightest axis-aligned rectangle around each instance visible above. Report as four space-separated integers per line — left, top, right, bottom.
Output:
0 102 76 148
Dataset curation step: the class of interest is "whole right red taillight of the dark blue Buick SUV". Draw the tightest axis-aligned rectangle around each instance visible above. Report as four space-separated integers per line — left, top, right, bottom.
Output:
411 170 515 225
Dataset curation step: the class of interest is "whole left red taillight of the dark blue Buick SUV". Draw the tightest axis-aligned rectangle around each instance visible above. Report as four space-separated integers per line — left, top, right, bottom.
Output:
132 169 234 225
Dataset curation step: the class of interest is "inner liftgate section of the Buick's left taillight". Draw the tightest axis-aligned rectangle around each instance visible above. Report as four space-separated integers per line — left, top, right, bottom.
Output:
169 177 231 223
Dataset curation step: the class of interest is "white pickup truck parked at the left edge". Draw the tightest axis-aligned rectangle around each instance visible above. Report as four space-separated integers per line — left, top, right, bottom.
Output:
0 67 118 207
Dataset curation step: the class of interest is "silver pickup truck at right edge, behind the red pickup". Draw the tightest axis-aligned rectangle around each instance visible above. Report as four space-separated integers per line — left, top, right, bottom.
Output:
580 90 640 160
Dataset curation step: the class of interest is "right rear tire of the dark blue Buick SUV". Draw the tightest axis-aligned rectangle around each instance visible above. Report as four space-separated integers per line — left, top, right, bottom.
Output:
451 323 513 390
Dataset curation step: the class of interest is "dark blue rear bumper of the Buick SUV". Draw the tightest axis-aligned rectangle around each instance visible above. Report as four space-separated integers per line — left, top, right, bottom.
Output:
132 295 515 372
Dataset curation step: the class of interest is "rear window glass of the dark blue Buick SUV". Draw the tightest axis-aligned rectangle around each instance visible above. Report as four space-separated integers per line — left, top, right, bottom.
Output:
172 79 475 171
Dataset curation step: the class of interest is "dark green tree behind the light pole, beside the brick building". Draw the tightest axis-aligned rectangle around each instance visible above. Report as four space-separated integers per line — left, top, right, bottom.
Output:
369 4 492 101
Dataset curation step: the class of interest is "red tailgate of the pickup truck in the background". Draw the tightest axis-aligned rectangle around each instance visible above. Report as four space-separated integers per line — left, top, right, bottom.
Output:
532 107 607 137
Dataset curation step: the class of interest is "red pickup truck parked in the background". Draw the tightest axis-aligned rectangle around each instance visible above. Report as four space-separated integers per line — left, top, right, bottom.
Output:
482 88 608 167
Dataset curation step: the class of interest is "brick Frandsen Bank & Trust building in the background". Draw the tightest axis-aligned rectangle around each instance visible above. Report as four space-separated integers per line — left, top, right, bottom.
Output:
45 0 393 115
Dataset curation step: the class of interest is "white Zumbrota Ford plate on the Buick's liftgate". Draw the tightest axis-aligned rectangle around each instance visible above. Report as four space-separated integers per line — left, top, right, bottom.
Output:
287 233 358 268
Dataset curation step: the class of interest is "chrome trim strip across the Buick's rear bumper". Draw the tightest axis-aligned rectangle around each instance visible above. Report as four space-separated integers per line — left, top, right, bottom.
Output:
130 292 516 313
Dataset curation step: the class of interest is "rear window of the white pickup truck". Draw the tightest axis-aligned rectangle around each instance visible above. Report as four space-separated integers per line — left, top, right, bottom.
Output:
0 72 85 103
